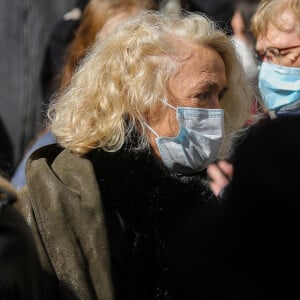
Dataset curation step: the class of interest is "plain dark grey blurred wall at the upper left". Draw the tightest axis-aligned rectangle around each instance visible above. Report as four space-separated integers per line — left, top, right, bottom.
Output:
0 0 75 171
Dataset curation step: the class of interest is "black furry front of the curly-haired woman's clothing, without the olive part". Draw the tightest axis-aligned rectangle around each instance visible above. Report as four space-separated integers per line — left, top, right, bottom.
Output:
89 148 215 300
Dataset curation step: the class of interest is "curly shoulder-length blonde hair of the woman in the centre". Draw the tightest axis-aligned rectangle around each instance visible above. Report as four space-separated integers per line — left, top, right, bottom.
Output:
48 10 254 155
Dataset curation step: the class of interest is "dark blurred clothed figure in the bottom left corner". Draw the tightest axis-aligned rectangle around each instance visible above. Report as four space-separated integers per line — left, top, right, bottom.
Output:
0 182 41 300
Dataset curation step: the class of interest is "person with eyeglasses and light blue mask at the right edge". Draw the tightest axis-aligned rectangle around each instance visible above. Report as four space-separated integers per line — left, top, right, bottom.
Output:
251 0 300 118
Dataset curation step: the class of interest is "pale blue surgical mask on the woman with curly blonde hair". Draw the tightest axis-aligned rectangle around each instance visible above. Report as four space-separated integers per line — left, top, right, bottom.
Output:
146 103 224 174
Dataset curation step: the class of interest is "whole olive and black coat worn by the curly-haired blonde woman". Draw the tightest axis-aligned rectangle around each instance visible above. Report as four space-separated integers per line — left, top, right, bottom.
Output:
15 145 215 300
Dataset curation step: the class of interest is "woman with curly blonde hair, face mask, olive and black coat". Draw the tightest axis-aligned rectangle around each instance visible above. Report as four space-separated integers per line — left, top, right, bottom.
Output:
19 11 253 300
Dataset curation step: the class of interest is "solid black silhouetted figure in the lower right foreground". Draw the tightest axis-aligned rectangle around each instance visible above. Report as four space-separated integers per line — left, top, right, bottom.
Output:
170 116 300 300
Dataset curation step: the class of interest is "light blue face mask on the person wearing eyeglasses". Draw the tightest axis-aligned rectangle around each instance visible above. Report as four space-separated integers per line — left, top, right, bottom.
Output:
258 62 300 111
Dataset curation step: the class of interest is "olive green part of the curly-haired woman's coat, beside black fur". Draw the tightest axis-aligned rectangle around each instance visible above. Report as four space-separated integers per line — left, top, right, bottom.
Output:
17 145 114 300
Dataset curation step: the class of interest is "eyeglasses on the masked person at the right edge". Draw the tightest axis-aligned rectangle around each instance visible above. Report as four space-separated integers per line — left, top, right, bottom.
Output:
255 45 300 65
